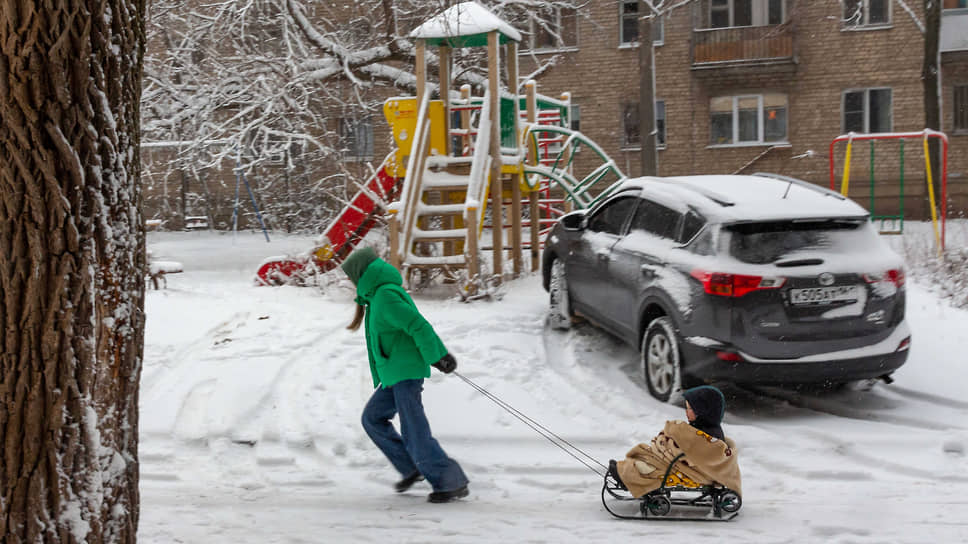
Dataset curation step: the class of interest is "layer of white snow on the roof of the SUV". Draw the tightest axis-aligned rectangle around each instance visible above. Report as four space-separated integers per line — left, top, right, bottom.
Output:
619 175 867 223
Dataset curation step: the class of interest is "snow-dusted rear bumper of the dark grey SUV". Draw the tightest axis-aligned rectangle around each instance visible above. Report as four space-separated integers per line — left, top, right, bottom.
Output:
682 322 910 384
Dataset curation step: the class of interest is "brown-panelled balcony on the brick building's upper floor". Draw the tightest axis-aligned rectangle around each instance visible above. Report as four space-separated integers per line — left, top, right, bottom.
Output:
692 22 796 75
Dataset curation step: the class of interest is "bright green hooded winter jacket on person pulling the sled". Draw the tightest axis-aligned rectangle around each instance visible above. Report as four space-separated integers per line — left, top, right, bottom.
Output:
356 259 447 387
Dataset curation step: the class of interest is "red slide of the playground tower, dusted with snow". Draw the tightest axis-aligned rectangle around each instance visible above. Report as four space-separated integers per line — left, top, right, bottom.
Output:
255 153 403 285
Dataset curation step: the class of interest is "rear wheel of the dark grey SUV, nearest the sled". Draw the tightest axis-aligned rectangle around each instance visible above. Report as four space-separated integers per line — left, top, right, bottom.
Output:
642 317 682 402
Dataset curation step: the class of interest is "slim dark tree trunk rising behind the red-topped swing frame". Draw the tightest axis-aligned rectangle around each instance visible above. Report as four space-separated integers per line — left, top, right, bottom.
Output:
921 0 947 211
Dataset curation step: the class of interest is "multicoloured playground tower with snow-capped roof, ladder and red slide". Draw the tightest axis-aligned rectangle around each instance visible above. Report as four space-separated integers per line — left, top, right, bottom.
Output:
256 2 625 288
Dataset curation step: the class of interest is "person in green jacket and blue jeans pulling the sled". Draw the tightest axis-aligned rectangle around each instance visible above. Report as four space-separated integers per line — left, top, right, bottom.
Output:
342 248 468 502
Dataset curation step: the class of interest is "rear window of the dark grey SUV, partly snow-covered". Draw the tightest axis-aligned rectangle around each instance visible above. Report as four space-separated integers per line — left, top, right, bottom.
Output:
725 219 868 264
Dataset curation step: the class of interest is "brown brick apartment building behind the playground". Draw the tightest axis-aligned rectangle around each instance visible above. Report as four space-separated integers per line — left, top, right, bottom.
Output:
146 0 968 228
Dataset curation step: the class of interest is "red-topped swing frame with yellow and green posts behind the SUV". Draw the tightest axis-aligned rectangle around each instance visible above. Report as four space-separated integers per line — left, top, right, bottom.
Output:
828 129 948 254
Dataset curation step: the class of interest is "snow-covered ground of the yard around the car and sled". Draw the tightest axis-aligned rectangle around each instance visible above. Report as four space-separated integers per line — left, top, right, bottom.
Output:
139 227 968 544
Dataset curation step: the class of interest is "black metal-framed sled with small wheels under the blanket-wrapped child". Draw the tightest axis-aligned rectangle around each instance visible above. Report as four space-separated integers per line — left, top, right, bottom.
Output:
602 454 743 521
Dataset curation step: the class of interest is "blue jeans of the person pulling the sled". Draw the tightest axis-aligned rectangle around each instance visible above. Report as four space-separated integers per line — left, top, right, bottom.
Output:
362 379 467 491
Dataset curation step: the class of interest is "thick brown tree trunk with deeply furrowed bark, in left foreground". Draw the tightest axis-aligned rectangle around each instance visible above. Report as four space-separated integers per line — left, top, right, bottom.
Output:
0 0 145 543
